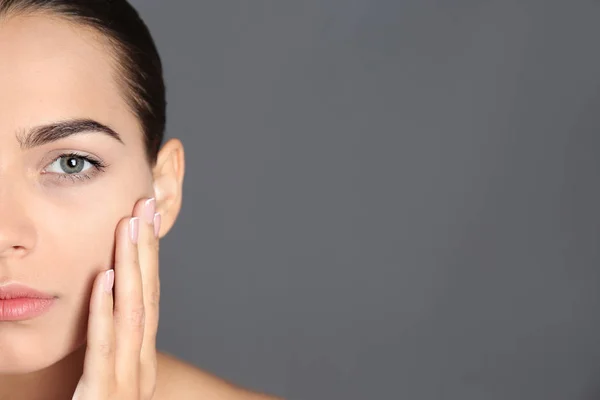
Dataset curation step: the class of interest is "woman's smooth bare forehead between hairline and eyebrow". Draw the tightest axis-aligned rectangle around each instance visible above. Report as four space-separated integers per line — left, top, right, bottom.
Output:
0 15 137 145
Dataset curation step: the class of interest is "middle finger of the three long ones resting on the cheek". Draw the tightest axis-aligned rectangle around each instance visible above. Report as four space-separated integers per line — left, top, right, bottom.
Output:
114 217 145 387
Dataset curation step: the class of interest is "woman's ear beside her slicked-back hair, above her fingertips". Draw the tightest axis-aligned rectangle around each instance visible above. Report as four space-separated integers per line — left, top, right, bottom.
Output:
152 139 185 238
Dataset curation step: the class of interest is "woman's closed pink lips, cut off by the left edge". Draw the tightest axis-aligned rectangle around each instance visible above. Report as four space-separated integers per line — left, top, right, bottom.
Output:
0 283 56 321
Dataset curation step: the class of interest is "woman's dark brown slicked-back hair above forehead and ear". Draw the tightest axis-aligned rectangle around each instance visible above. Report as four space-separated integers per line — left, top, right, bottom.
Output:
0 0 167 166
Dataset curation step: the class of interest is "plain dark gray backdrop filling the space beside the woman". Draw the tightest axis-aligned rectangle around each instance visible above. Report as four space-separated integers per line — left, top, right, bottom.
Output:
133 0 600 400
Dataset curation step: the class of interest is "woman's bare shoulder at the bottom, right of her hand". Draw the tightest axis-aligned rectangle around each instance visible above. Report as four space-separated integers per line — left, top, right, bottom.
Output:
154 352 282 400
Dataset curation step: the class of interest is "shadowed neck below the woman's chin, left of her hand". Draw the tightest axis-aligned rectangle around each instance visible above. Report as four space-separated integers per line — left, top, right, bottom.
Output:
0 345 85 400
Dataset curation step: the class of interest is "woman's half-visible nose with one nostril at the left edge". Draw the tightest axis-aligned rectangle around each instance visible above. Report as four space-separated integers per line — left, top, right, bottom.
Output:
0 190 36 261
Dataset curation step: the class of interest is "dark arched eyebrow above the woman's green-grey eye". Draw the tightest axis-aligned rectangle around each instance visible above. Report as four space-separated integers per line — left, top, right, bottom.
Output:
17 119 125 150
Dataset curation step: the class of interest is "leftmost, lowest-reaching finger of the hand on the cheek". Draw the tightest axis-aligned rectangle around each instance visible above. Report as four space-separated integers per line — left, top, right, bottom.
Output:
81 269 115 398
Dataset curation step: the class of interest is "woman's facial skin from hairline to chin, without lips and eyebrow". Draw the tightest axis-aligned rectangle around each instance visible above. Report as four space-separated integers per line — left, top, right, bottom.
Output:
0 15 159 373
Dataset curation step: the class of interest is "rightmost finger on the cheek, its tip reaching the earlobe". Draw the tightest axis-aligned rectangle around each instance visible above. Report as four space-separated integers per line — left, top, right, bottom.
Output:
134 198 161 382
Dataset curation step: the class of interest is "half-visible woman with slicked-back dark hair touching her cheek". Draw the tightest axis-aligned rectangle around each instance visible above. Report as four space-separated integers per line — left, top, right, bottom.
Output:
0 0 282 400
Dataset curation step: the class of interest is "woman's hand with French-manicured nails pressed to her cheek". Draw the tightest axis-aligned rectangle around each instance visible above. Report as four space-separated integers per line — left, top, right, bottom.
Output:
73 199 160 400
